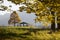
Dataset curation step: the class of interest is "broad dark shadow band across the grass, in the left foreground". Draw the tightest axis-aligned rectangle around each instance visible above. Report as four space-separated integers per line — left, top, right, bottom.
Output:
0 32 31 38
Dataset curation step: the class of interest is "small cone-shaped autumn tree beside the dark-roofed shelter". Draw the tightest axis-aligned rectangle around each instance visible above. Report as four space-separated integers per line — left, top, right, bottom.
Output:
8 11 21 26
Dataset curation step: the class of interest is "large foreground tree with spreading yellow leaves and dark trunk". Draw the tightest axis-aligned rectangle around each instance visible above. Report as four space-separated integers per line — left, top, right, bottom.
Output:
6 0 60 31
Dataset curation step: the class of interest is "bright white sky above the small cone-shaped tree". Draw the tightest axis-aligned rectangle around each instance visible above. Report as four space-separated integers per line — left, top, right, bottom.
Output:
0 0 25 15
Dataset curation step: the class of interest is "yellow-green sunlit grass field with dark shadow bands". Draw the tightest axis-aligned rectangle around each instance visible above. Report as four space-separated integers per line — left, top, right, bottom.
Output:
0 27 60 40
